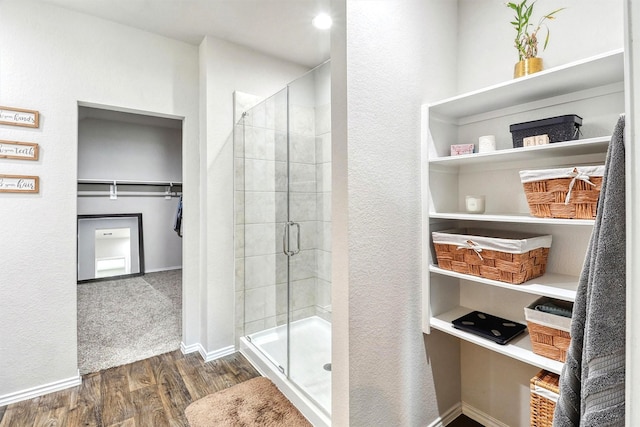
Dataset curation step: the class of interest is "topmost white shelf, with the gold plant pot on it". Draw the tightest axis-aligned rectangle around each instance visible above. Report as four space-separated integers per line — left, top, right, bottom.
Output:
429 49 624 120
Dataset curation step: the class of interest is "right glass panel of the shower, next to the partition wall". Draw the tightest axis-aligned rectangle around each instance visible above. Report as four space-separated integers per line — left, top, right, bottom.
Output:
289 63 331 410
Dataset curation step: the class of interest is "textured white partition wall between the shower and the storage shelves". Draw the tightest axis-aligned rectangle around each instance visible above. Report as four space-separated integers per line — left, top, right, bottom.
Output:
331 0 460 426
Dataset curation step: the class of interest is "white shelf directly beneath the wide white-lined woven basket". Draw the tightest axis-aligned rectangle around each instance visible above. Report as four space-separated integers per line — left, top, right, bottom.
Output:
429 265 579 302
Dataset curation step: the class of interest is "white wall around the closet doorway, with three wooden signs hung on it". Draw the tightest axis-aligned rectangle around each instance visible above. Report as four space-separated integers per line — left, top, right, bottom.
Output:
0 0 199 401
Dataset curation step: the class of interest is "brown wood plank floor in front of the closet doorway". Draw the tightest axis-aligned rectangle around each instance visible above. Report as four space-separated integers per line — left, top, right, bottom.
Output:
0 350 260 427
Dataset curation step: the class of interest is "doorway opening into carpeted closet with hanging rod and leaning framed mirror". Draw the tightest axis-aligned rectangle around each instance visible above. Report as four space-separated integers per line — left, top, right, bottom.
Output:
77 106 182 375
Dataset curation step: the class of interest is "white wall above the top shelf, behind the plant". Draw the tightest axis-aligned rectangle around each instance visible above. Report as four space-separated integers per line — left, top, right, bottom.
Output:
454 0 623 93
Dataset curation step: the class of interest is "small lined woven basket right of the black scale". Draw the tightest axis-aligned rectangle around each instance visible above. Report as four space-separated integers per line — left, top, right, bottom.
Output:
524 297 573 362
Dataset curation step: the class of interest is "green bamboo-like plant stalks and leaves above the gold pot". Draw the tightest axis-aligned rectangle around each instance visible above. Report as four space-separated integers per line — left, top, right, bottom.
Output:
507 0 564 61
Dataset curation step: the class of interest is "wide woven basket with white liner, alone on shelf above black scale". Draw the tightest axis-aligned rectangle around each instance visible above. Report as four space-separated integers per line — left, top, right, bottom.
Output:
432 229 551 285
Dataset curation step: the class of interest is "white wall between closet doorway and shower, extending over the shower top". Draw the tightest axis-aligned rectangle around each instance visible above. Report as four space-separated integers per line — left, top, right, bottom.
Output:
200 37 307 355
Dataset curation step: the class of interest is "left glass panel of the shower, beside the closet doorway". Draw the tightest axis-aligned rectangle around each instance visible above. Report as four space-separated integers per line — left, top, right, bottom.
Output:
236 88 288 373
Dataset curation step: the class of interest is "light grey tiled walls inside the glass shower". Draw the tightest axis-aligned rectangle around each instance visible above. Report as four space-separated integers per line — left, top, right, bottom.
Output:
234 80 331 337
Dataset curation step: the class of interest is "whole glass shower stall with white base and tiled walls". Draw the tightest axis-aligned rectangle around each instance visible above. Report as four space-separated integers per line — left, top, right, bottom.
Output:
234 62 331 419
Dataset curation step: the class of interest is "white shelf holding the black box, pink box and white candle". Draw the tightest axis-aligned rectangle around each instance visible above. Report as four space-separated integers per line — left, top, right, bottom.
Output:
429 135 611 166
